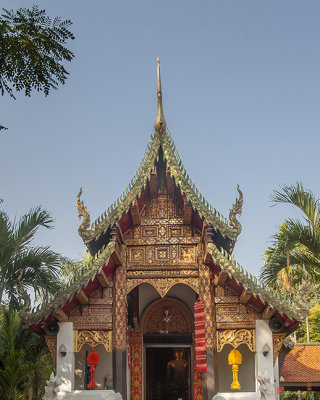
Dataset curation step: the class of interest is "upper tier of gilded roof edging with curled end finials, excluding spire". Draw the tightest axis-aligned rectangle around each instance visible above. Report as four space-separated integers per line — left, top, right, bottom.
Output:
77 130 242 244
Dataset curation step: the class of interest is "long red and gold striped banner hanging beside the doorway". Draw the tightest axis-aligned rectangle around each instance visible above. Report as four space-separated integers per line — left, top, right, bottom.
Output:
194 300 207 372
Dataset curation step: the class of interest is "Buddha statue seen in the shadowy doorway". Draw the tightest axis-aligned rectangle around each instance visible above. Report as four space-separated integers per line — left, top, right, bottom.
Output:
166 348 189 400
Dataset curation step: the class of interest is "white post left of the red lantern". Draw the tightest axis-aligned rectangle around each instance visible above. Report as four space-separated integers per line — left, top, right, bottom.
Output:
57 322 74 392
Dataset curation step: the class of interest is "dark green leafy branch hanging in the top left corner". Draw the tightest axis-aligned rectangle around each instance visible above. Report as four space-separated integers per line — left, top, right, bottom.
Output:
0 6 74 97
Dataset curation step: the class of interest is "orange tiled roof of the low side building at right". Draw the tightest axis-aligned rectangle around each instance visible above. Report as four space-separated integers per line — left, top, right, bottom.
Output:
280 343 320 383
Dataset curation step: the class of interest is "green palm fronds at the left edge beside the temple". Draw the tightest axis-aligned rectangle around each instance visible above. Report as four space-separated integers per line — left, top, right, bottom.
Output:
0 207 60 311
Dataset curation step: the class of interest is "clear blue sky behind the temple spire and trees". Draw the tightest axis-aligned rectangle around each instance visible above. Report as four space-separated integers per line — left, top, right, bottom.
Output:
0 0 320 275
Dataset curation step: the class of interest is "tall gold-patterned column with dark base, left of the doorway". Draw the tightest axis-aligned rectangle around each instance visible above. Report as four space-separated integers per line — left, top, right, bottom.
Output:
112 265 128 400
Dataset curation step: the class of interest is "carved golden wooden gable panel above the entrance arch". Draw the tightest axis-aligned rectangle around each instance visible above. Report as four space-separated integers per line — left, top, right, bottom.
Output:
124 189 200 296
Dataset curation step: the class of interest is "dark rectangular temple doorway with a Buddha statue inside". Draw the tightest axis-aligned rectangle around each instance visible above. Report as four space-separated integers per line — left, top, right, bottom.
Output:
146 345 192 400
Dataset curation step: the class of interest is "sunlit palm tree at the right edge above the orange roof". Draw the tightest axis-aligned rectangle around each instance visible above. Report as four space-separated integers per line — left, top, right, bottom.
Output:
261 183 320 294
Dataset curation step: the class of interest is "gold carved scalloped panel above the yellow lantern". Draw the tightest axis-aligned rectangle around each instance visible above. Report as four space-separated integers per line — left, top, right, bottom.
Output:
217 329 256 352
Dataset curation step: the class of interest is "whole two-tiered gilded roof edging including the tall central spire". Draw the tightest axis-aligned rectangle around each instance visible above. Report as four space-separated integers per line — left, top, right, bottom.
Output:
29 60 307 329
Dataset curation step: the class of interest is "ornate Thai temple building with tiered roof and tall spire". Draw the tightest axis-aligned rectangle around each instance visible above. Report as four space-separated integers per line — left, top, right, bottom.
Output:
29 60 305 400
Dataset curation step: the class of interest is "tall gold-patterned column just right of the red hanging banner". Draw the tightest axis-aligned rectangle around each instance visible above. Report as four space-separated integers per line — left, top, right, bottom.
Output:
199 250 218 400
